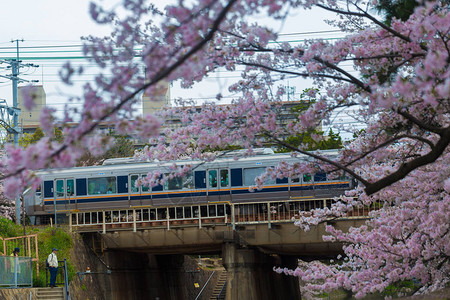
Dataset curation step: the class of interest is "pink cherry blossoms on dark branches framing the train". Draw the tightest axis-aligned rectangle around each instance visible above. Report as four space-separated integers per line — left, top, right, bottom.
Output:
0 0 450 296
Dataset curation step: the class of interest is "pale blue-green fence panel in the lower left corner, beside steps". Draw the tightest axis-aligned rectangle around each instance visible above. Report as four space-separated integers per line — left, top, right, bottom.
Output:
0 256 33 288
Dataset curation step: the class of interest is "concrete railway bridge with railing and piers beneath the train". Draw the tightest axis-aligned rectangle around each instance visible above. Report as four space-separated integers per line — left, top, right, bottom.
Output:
69 198 370 299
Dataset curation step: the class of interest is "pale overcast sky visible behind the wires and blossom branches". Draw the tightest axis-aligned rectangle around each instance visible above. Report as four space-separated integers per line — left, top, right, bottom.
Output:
0 0 356 132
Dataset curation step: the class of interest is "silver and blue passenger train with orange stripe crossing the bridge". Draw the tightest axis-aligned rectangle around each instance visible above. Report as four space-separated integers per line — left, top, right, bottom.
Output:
24 149 353 224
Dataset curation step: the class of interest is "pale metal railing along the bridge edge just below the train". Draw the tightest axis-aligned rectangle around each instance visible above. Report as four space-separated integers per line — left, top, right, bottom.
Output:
69 198 379 233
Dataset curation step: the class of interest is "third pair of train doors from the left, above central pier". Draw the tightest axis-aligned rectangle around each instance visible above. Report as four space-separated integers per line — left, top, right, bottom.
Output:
207 169 231 201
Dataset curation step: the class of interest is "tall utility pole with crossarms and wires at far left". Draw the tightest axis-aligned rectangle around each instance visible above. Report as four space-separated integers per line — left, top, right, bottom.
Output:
0 39 39 224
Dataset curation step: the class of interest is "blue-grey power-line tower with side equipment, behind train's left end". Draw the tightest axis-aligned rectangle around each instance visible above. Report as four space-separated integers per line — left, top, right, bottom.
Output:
0 39 39 224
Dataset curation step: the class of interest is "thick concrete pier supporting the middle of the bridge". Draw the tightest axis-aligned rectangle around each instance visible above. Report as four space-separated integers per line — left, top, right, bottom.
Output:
222 243 300 300
